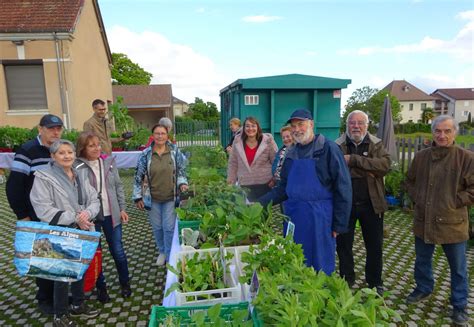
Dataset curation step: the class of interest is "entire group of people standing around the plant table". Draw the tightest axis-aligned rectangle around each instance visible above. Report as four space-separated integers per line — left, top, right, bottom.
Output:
6 99 474 326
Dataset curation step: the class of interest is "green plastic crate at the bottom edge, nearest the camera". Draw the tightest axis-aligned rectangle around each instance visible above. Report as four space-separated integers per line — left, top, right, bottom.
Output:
148 302 253 327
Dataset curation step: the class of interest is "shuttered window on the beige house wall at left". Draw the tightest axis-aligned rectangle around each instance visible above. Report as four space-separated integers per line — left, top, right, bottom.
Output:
2 60 48 110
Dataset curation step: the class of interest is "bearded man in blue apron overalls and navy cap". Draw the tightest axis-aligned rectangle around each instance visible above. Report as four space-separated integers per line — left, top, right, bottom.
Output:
259 109 352 274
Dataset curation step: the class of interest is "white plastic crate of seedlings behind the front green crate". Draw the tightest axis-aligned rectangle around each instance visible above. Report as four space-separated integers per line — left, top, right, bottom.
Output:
170 248 242 306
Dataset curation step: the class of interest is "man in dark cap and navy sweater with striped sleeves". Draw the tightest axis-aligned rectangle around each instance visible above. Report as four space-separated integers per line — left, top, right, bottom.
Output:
6 114 63 314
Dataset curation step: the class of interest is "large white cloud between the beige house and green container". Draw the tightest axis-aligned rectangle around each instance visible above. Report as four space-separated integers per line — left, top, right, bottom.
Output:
107 25 230 107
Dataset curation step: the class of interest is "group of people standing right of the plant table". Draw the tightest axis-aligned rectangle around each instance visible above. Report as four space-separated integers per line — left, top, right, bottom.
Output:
226 109 474 326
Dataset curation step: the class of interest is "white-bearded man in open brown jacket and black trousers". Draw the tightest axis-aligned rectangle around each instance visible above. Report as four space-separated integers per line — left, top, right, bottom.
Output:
336 110 390 296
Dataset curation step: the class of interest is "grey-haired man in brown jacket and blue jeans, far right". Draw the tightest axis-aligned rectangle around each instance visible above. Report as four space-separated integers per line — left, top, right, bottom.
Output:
407 115 474 326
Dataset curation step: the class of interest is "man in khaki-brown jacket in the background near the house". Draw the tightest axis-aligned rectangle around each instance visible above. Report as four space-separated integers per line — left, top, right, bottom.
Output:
83 99 124 155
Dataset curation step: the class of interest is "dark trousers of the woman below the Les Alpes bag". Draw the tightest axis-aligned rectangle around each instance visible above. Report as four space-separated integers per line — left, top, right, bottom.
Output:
54 279 84 316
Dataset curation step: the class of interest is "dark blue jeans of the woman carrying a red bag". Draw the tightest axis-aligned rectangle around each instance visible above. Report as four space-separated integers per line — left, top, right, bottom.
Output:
95 216 130 288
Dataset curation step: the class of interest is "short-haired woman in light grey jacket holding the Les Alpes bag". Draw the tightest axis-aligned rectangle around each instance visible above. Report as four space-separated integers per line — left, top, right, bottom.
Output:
30 140 100 326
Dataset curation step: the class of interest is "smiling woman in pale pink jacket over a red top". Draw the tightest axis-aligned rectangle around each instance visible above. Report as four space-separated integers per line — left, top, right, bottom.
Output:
227 117 278 202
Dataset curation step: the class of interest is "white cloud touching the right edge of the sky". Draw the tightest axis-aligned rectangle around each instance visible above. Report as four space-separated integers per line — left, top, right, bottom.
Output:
337 10 474 62
